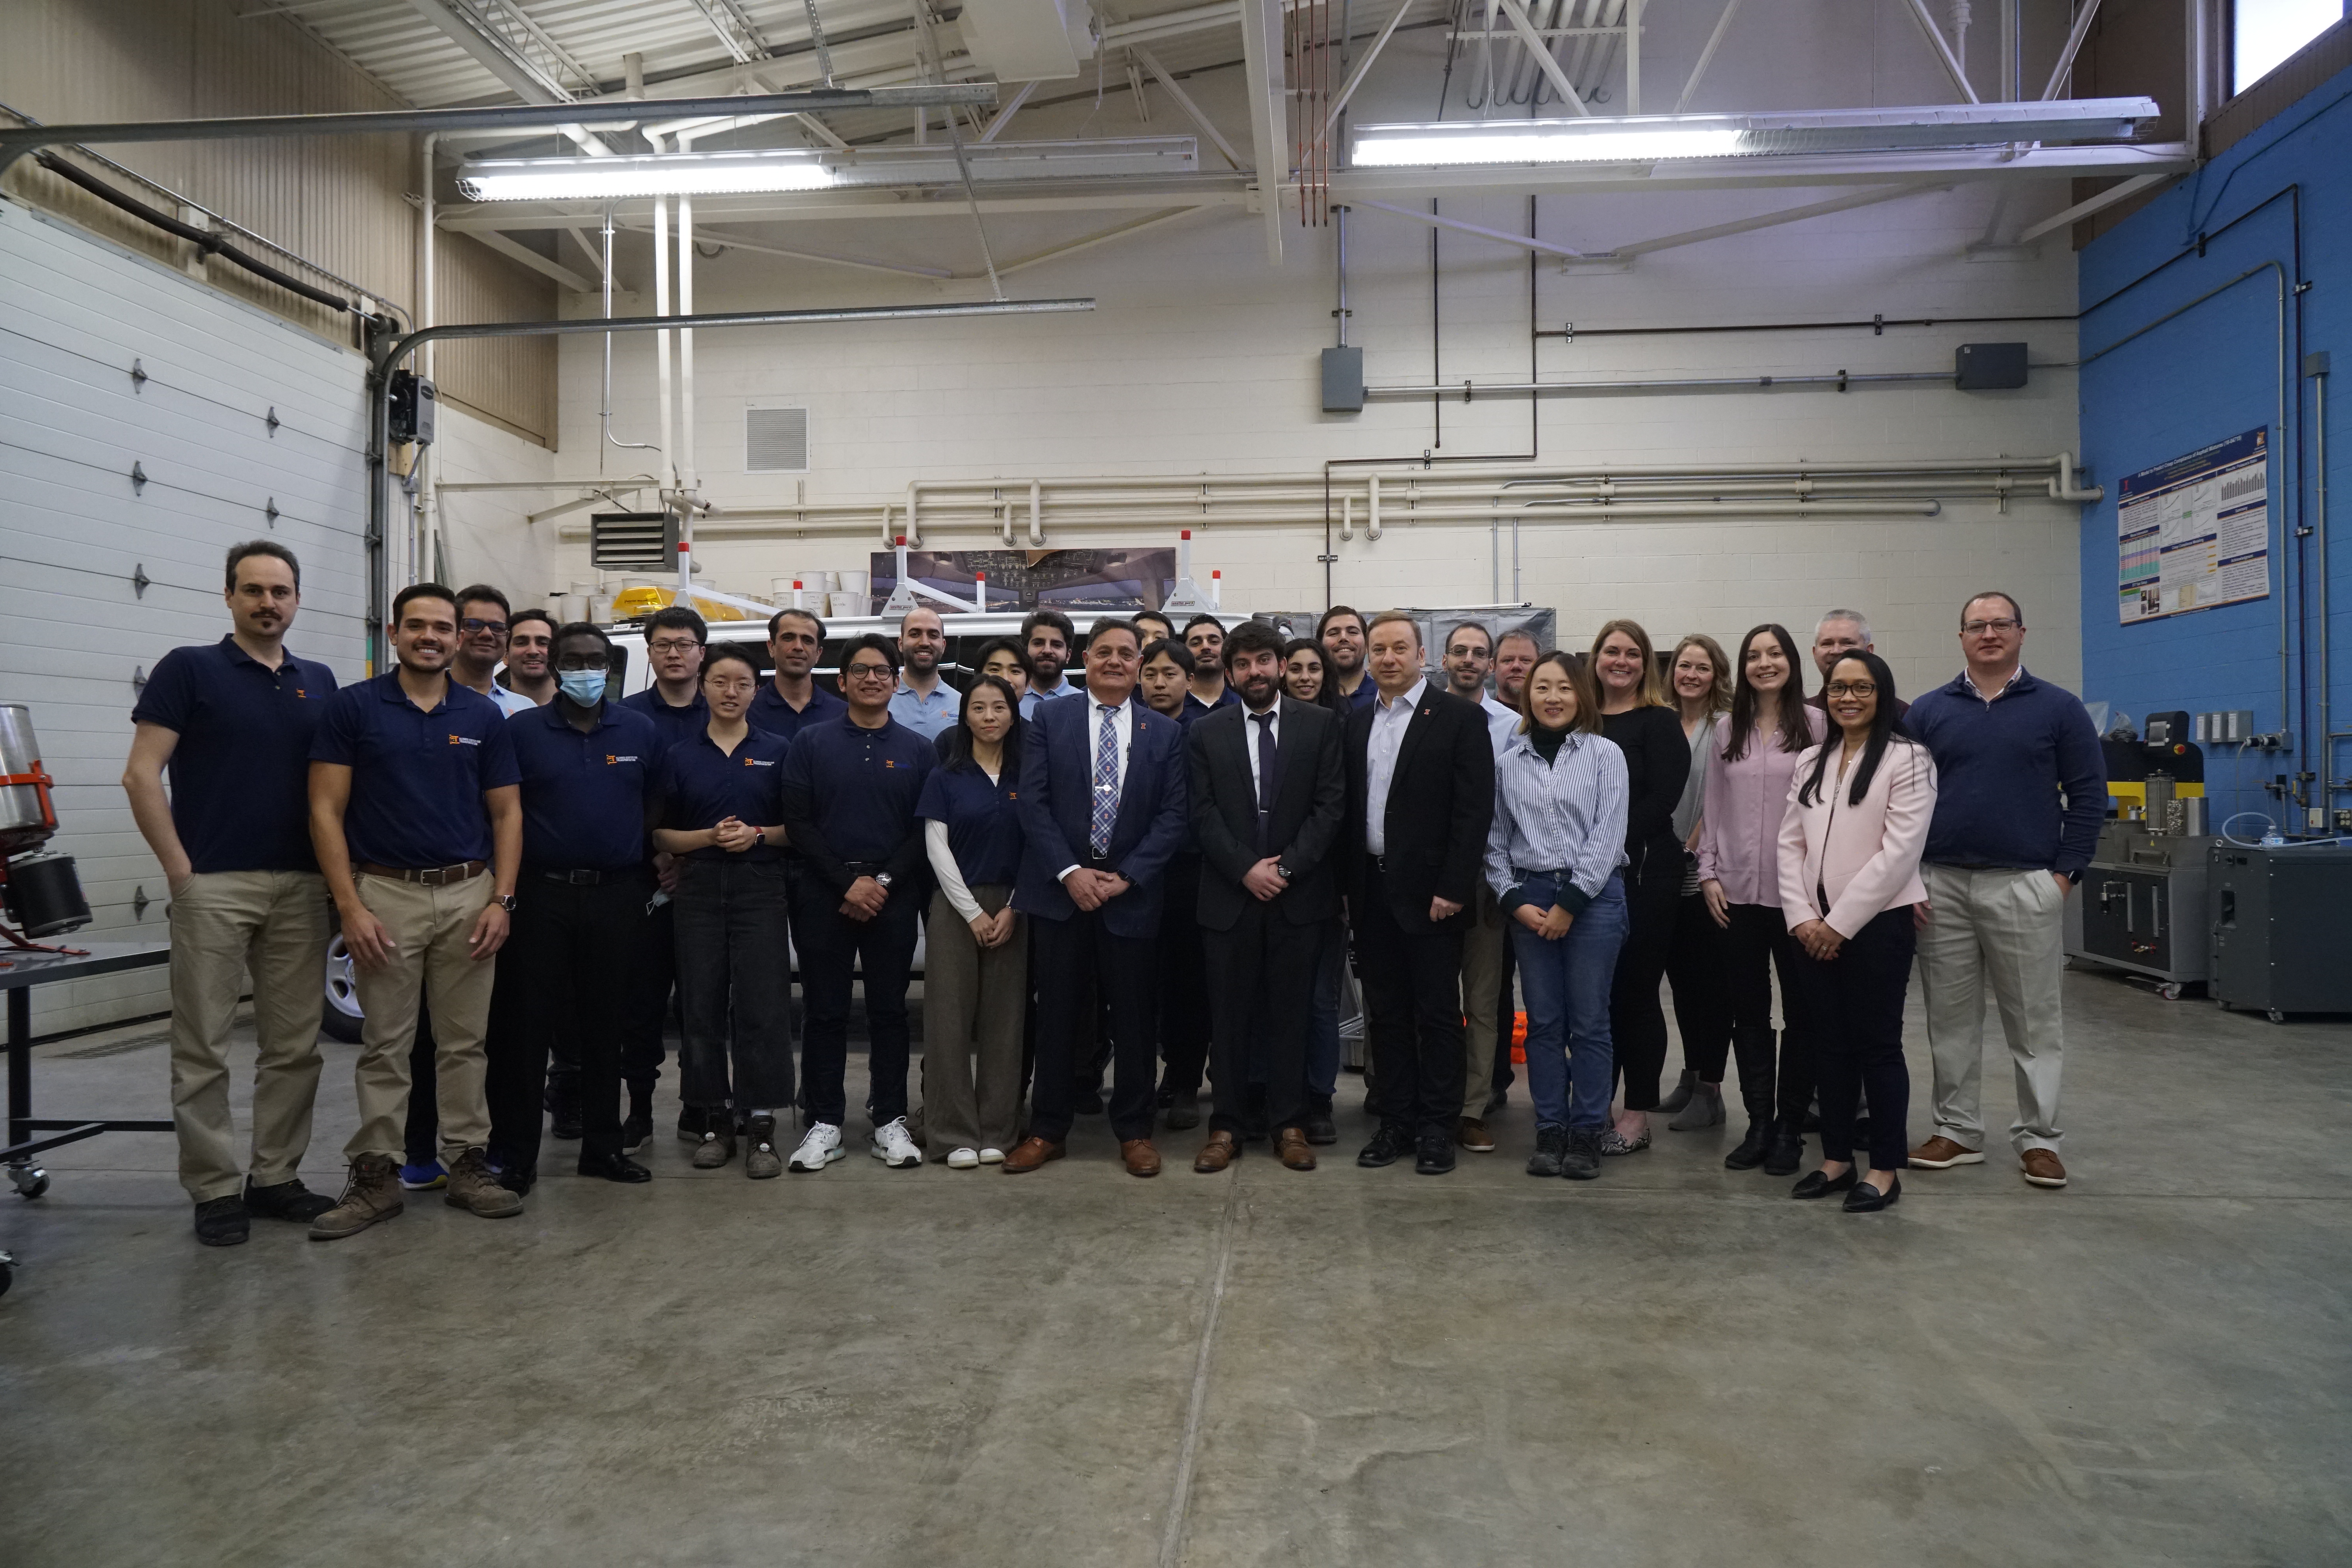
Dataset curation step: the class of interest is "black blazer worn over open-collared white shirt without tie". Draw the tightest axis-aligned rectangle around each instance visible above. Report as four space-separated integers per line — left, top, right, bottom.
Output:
1345 682 1494 931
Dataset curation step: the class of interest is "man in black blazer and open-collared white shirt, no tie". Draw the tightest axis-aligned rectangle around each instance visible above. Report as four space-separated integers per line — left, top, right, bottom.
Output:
1348 611 1494 1176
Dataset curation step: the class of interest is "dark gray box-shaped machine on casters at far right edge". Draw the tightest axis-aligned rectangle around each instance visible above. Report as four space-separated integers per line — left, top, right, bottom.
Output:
2206 839 2352 1023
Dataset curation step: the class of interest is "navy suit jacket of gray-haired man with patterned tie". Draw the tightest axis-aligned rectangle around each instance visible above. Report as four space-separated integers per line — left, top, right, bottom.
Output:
1014 691 1188 938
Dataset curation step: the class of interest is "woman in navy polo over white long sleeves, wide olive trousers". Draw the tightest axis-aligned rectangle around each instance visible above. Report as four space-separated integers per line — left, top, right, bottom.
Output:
915 675 1028 1171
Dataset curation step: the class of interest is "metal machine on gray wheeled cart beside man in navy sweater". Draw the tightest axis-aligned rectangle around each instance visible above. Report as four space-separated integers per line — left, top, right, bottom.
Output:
2065 712 2213 1002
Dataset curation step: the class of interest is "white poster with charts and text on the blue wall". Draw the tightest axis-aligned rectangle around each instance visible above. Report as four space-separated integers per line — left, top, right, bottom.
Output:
2114 425 2270 625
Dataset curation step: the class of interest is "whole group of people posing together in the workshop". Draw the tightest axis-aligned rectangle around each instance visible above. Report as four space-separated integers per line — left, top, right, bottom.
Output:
125 541 2105 1246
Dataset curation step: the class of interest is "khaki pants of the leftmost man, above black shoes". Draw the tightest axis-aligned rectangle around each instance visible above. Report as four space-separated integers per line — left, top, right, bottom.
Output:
172 872 327 1203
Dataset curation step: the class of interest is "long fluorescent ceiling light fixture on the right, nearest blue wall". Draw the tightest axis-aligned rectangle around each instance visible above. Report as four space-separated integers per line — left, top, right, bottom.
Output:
1350 99 2157 169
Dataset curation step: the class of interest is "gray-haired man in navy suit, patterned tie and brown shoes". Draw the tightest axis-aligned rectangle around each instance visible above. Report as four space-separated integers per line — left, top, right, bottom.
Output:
1004 621 1195 1176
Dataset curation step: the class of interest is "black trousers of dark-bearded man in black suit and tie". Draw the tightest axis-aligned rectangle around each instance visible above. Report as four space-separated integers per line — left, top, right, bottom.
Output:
1200 898 1322 1138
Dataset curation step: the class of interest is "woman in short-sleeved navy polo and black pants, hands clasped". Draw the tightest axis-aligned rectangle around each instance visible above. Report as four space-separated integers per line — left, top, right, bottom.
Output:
654 644 793 1178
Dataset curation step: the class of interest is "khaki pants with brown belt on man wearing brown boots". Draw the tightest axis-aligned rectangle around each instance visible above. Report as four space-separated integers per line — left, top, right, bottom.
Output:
343 872 499 1164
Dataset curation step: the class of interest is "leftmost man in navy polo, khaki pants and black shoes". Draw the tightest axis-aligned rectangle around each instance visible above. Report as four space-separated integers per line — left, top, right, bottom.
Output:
122 541 334 1246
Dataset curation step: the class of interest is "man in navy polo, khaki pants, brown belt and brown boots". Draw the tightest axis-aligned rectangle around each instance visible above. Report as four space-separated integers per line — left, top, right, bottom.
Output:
310 583 522 1241
